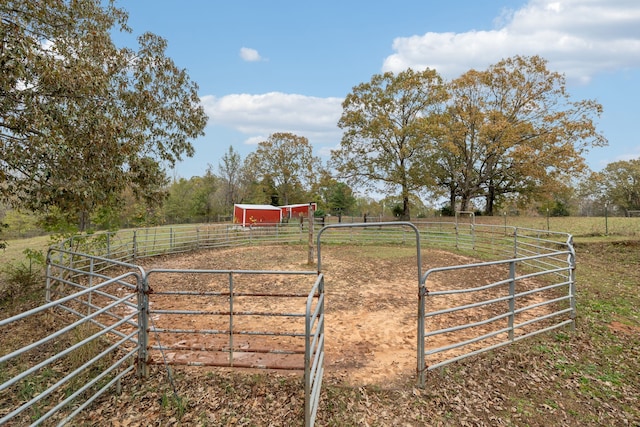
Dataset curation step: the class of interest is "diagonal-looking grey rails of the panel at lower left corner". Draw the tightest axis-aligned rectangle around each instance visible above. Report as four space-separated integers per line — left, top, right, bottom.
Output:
0 272 139 425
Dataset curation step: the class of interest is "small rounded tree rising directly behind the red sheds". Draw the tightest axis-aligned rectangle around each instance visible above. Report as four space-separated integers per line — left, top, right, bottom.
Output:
246 133 321 205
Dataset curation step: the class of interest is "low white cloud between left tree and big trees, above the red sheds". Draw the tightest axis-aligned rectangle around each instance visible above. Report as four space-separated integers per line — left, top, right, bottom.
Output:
201 92 343 144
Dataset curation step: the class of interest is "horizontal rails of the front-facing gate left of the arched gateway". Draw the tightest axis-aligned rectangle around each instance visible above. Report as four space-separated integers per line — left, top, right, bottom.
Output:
145 269 318 370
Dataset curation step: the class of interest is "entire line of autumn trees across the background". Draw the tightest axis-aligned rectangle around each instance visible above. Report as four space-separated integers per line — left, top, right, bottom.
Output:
0 0 640 241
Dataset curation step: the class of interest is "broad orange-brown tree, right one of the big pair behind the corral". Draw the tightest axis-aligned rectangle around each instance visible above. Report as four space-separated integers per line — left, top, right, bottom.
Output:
433 56 607 215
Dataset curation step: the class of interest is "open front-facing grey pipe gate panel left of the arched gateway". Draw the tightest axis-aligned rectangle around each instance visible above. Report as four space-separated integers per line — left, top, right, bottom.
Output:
145 269 319 371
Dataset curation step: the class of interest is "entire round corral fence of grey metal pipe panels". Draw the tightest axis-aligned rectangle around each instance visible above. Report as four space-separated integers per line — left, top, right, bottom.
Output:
0 221 575 425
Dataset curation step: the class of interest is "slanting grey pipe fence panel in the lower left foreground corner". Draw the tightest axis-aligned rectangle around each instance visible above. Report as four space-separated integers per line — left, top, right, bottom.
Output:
0 272 140 425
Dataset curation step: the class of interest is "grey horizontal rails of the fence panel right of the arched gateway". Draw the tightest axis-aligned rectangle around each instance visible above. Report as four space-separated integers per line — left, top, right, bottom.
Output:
419 246 575 384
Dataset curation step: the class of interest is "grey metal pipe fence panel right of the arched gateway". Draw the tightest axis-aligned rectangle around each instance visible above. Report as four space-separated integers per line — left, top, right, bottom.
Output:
418 244 576 386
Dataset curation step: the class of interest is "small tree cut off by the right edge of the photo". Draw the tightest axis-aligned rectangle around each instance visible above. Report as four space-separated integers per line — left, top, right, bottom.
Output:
600 159 640 214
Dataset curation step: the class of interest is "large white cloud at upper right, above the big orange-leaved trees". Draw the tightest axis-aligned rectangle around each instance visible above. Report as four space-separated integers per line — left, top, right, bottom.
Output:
383 0 640 82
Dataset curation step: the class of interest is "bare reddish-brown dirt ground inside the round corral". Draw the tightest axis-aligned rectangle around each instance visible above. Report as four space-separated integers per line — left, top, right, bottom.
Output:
132 246 552 387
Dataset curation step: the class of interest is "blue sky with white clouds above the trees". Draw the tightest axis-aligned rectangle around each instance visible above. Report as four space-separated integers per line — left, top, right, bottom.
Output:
114 0 640 178
